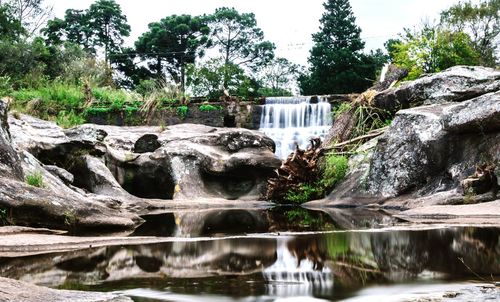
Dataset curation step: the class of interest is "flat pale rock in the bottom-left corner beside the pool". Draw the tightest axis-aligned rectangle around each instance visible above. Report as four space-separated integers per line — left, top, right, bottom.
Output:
0 277 132 302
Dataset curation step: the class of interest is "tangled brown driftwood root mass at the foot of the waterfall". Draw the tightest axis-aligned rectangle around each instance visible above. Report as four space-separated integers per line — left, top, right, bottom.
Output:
265 138 323 201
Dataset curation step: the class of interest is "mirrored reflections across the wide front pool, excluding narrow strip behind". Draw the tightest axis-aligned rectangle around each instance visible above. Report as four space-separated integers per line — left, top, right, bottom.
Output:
0 224 500 300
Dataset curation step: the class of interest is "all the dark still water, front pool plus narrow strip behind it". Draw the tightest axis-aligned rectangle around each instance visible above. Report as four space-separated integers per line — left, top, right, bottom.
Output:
0 209 500 301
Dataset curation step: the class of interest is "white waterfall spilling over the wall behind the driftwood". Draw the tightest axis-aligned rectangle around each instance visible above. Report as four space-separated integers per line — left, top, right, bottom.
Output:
259 97 332 159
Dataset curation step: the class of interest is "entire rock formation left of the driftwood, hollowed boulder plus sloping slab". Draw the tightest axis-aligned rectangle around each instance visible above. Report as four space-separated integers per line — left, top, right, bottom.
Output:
0 101 281 231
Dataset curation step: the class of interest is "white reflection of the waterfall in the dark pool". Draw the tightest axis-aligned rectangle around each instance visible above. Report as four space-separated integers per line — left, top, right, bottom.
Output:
263 238 333 297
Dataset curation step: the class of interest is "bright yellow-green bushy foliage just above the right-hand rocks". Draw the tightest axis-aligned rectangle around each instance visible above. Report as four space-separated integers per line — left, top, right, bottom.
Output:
393 25 479 80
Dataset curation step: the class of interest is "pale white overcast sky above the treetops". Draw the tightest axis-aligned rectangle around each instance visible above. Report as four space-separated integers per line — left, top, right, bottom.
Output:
45 0 468 65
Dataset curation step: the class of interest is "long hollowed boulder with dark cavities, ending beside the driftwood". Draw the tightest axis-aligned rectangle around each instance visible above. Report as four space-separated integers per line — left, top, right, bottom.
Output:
6 115 281 206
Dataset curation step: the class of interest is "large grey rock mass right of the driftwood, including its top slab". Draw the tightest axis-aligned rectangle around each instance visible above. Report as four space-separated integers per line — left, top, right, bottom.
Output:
311 66 500 214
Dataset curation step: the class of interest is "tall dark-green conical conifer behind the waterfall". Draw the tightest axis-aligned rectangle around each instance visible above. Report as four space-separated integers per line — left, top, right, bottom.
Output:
299 0 375 94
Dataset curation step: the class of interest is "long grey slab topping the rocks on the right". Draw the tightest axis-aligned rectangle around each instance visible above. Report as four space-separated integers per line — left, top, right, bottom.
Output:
373 66 500 112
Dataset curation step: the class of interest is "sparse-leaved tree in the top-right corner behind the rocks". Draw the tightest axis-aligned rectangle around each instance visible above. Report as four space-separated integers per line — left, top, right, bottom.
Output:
441 0 500 66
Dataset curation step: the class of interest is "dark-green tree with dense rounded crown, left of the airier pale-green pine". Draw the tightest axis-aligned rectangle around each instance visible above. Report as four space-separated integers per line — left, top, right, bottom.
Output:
135 15 210 92
